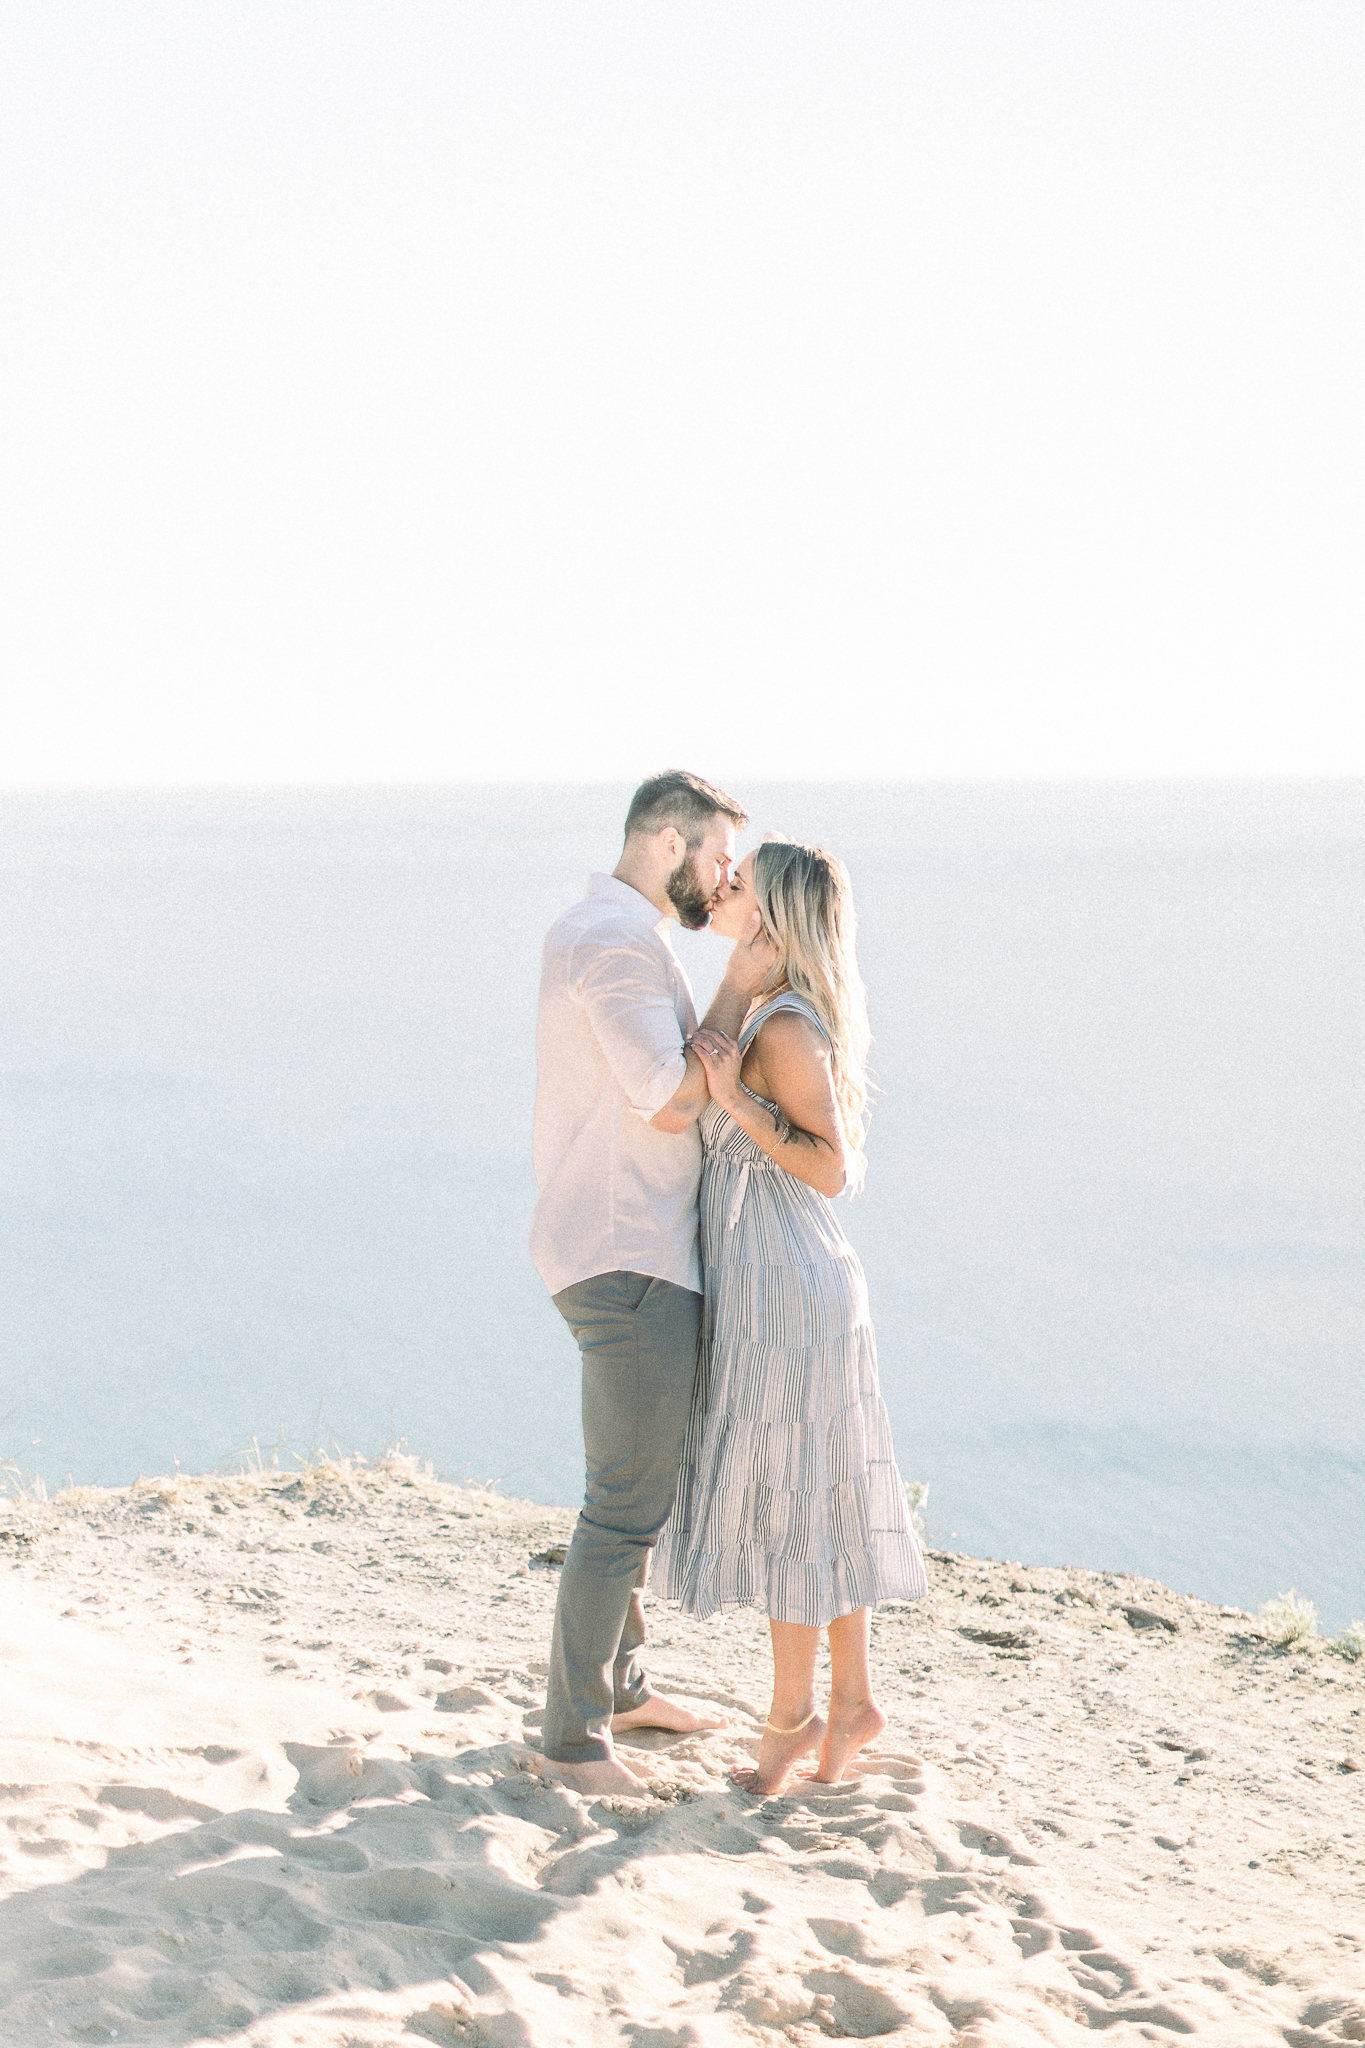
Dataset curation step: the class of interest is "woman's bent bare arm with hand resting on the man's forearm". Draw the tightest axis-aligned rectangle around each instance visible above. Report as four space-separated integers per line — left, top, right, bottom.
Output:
692 1010 849 1196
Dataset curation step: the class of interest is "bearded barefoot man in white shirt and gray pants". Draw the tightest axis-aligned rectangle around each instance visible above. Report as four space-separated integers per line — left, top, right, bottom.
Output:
530 770 772 1794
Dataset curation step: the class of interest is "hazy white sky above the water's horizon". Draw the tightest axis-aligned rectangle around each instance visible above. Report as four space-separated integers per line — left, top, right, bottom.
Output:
0 0 1365 784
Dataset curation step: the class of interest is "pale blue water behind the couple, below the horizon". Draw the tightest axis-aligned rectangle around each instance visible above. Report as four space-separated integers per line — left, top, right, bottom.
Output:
0 784 1365 1622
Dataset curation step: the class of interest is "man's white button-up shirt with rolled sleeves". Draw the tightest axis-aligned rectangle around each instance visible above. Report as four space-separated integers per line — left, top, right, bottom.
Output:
530 874 702 1294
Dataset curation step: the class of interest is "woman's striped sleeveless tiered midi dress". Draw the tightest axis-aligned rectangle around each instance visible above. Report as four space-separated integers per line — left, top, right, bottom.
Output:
653 991 929 1628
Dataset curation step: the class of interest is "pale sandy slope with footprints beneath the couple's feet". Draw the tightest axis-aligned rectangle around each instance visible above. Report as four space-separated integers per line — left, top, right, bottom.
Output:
0 1466 1365 2048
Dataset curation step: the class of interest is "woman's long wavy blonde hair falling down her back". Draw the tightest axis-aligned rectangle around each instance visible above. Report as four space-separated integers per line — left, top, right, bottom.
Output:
753 838 872 1192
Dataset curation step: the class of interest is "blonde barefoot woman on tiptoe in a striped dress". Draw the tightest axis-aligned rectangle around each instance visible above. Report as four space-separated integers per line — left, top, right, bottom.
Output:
655 840 927 1794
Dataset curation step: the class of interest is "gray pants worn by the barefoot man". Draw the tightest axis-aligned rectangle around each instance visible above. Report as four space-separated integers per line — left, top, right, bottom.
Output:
544 1274 702 1763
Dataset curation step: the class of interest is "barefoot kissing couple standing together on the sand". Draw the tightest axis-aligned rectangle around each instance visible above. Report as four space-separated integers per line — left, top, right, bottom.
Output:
530 770 927 1794
